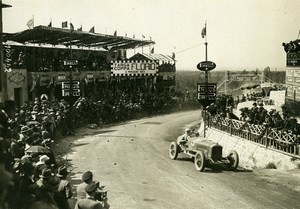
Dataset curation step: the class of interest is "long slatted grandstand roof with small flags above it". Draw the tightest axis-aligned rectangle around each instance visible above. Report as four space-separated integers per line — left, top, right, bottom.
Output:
3 25 155 50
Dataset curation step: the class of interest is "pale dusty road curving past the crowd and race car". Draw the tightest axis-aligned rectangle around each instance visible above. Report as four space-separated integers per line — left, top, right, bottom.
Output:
68 111 300 209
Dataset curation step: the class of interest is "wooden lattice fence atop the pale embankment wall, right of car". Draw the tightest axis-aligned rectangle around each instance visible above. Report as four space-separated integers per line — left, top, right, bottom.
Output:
207 116 300 157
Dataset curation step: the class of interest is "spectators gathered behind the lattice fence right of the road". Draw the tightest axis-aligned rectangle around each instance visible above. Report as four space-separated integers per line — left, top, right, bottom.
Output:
207 95 300 135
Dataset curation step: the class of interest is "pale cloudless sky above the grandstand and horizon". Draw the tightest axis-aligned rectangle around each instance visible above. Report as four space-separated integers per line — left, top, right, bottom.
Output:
2 0 300 70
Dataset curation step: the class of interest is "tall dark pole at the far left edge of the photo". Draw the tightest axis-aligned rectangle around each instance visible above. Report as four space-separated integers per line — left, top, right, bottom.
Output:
0 0 11 102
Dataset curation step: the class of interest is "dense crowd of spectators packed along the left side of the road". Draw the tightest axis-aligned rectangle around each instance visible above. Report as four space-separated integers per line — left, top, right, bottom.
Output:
0 88 198 209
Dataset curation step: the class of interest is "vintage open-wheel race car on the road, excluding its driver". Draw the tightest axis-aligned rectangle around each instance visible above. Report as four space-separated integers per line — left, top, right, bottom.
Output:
169 137 239 171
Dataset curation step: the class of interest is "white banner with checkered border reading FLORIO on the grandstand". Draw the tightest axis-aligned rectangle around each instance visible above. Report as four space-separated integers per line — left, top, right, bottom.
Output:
111 60 158 76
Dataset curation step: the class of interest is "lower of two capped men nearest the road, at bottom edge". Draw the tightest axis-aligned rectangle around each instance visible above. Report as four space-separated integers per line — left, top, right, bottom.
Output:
74 182 109 209
